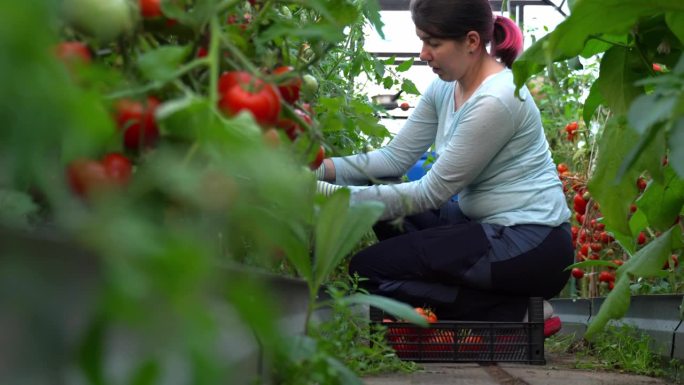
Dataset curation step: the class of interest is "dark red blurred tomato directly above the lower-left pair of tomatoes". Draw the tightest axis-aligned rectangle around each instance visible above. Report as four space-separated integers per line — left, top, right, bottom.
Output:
115 97 159 151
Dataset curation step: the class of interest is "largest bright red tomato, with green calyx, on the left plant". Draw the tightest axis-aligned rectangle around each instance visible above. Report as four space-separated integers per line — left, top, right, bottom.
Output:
219 80 281 126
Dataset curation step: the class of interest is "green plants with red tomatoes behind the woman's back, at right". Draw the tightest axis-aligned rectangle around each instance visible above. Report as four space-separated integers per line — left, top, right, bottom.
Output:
513 0 684 339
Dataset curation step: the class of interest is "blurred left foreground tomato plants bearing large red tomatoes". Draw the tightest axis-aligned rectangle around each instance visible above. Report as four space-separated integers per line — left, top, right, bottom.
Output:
0 0 422 383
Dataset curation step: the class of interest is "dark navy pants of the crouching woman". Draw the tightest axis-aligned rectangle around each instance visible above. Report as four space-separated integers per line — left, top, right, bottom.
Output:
349 209 574 322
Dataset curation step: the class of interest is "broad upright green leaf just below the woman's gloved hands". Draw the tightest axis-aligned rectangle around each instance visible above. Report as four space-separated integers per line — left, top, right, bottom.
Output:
314 189 384 288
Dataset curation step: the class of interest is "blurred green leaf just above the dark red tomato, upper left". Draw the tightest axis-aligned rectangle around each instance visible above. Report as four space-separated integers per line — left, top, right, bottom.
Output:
138 45 191 82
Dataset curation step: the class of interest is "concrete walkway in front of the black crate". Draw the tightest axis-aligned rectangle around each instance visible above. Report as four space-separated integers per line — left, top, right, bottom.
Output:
364 353 672 385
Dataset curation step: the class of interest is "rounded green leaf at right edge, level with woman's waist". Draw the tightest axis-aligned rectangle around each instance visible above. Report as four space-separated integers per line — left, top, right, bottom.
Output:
639 167 684 231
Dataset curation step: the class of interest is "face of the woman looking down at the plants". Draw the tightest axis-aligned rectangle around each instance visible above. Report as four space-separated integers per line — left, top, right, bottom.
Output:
416 28 473 82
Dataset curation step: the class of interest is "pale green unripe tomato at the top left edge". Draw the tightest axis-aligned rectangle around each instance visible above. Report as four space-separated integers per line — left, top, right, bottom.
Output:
62 0 136 42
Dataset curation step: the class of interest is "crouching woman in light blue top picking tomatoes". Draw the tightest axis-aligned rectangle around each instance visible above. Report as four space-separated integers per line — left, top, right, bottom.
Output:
317 0 573 328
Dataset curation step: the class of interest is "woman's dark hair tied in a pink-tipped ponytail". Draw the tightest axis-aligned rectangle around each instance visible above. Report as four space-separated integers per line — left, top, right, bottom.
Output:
410 0 522 67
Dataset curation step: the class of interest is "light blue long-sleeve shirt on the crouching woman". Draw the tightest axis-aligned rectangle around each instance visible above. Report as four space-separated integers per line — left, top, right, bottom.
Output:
332 69 570 226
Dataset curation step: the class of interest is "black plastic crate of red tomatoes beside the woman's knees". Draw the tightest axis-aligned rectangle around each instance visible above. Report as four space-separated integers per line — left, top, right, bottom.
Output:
370 297 546 365
